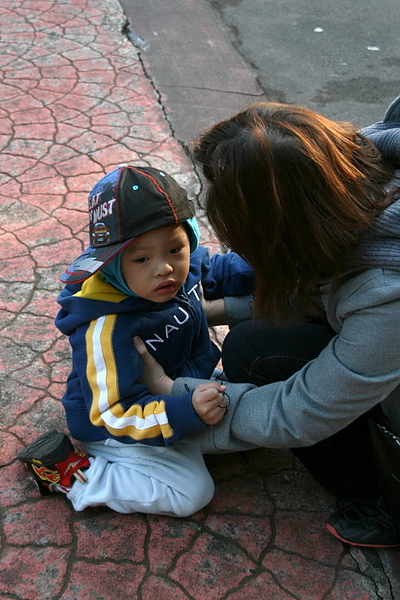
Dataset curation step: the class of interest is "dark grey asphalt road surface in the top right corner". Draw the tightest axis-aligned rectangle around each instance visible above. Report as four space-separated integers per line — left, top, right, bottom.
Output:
209 0 400 125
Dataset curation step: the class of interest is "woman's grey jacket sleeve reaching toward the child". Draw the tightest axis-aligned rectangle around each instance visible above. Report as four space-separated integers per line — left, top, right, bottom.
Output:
173 269 400 453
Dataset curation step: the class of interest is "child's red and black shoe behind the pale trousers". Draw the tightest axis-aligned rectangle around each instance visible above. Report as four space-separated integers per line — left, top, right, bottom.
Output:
18 431 90 496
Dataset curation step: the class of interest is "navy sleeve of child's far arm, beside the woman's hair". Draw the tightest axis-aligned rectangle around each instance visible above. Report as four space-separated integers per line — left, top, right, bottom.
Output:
191 247 254 300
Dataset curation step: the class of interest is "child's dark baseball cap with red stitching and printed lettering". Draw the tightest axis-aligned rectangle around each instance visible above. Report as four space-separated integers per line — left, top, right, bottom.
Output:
60 165 195 283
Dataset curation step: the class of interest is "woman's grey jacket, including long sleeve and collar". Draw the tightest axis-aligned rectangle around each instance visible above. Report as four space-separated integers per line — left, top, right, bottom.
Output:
174 97 400 452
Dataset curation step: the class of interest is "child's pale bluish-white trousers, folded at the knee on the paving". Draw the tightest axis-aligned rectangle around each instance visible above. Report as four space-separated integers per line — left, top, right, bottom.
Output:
67 439 214 517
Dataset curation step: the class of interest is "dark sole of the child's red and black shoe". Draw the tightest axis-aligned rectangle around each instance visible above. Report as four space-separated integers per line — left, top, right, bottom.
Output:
18 431 71 466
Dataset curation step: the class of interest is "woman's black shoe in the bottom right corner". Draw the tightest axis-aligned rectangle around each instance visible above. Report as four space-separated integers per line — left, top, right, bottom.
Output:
326 504 400 548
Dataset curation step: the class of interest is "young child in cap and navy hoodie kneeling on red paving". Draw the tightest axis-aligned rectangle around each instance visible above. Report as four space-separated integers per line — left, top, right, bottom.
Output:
19 165 254 516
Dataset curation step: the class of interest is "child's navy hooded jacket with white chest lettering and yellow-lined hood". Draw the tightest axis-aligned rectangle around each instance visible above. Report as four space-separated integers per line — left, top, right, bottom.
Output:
56 247 254 446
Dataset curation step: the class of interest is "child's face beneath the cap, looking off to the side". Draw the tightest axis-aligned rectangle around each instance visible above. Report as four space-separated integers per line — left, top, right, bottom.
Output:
121 225 190 302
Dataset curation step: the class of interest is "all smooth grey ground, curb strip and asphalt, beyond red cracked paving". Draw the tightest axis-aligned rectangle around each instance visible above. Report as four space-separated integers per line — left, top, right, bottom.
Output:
120 0 400 142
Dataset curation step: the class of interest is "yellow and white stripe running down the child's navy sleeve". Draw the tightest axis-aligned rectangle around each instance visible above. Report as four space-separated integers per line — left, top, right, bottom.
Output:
86 315 173 441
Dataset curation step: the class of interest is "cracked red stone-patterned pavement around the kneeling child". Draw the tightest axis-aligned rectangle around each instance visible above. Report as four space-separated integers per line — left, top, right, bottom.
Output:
0 0 398 600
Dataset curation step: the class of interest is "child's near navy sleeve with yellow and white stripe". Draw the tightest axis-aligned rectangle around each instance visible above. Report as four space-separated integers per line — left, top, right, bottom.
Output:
64 314 206 446
